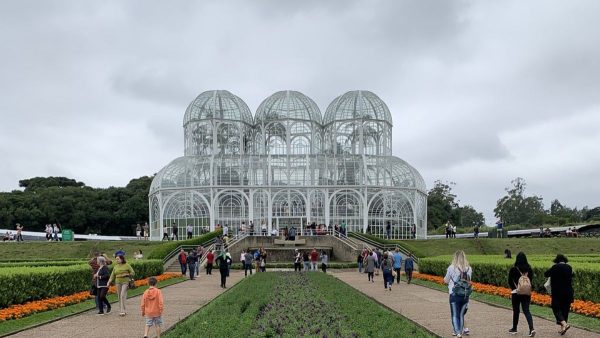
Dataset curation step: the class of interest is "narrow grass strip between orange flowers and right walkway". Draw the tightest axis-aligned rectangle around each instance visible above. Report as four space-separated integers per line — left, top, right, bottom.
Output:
402 276 600 333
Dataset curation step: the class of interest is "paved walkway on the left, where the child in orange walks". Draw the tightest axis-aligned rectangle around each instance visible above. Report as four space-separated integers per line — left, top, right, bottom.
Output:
9 269 244 338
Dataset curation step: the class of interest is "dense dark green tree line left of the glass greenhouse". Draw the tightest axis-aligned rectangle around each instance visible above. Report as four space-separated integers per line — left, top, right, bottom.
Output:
0 176 153 235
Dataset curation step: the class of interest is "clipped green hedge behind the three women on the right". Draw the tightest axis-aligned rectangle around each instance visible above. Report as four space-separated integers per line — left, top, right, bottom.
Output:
419 255 600 302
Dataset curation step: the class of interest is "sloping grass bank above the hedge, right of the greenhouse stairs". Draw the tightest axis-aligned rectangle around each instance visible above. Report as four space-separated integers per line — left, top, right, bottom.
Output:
356 236 600 257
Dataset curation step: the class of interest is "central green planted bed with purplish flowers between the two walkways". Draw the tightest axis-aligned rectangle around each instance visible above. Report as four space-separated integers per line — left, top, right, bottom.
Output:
165 272 433 337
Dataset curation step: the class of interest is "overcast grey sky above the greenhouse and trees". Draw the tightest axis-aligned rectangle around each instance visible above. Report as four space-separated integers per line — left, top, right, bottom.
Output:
0 0 600 224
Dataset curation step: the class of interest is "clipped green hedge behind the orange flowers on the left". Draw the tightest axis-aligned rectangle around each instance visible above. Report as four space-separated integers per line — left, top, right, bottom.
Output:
0 260 163 308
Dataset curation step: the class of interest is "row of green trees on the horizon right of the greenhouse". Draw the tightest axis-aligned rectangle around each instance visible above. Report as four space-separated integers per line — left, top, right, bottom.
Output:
427 177 600 229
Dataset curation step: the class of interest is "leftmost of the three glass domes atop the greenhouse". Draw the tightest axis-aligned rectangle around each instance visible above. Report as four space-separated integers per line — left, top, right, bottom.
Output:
183 90 253 126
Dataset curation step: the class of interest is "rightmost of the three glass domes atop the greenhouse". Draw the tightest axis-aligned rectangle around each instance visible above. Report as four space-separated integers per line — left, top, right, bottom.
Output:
323 90 393 126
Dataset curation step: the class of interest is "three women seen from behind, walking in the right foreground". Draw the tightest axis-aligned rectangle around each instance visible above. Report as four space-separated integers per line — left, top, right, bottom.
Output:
444 250 574 338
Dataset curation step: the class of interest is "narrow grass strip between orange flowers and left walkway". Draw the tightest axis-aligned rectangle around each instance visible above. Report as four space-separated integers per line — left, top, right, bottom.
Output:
0 277 187 336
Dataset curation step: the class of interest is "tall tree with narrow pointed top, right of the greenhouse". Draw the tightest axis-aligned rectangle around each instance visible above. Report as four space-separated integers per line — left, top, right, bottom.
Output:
494 177 545 225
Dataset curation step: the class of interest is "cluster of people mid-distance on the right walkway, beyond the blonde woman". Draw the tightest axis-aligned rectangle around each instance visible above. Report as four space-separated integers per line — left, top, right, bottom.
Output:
356 248 414 291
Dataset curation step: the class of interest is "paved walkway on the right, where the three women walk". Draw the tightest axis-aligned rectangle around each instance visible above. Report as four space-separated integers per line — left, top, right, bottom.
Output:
330 270 600 338
